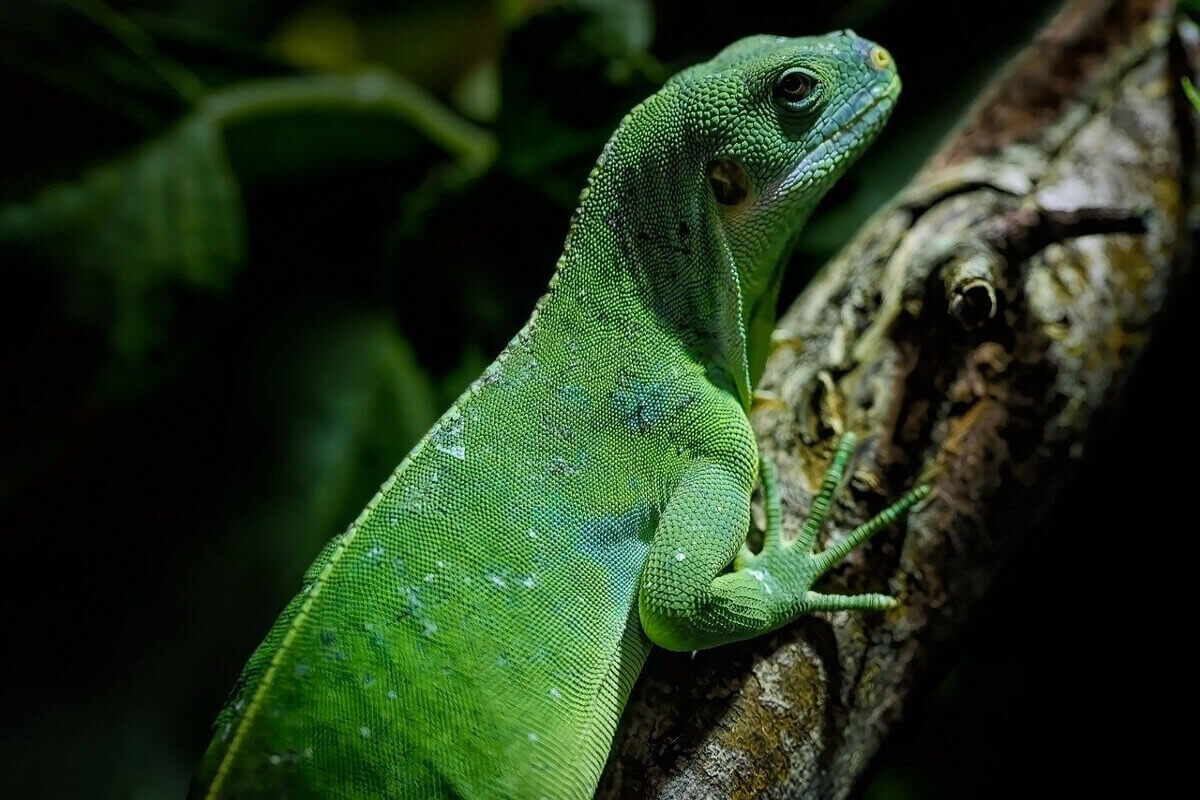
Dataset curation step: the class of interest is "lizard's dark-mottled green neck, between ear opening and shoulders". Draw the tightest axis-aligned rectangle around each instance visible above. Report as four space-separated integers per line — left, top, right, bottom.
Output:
552 92 750 408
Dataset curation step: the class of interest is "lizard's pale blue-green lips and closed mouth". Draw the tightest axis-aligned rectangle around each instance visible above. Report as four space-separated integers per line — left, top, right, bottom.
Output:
770 74 900 200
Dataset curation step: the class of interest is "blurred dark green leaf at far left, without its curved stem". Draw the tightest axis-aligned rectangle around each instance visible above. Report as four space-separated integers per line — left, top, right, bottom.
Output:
0 116 246 361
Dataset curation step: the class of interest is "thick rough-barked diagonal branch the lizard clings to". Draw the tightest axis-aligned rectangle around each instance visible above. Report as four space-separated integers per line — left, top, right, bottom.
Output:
600 0 1198 798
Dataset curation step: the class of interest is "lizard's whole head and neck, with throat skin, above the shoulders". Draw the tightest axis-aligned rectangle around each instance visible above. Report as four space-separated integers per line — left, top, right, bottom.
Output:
563 31 900 408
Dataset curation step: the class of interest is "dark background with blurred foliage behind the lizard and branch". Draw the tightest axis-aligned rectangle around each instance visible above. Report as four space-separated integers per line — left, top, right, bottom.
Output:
0 0 1180 800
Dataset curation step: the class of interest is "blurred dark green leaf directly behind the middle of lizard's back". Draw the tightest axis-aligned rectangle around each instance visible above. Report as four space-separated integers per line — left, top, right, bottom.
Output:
214 312 439 594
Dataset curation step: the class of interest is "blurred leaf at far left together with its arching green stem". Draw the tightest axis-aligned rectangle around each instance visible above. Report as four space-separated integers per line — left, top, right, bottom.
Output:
0 71 494 386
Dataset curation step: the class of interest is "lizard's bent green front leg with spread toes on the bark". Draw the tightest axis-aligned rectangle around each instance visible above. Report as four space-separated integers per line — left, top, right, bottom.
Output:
638 434 929 650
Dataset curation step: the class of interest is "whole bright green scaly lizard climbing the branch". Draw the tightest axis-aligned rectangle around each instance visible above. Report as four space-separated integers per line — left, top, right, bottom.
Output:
193 31 924 800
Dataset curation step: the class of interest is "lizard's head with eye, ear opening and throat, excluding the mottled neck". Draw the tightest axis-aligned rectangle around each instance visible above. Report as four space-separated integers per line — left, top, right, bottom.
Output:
662 31 900 384
